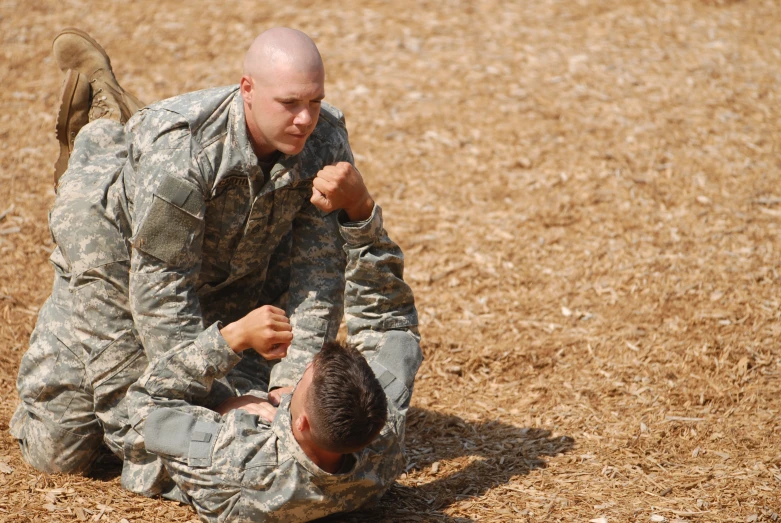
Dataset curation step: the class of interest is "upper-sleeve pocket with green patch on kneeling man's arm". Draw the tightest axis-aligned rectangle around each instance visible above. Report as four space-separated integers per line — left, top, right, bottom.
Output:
133 176 204 265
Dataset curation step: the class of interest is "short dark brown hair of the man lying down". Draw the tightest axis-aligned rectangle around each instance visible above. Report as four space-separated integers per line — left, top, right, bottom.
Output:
306 342 388 454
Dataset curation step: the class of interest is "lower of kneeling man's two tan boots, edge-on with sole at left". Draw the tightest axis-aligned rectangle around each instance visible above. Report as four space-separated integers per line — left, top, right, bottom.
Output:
54 69 90 189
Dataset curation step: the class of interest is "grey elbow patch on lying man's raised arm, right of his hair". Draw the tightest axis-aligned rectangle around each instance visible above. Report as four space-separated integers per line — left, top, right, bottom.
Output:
369 331 423 408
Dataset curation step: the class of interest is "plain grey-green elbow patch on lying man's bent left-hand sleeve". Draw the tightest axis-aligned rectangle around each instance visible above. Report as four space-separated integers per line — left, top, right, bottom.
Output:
144 408 220 467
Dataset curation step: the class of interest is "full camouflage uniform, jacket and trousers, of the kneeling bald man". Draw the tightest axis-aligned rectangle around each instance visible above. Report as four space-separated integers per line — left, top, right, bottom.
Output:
11 86 353 472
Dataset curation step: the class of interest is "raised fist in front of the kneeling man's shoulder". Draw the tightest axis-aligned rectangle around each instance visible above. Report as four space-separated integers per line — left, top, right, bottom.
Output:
309 162 374 222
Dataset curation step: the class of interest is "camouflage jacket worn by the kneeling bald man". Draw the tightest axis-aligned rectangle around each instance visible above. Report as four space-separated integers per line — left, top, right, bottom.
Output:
121 86 353 386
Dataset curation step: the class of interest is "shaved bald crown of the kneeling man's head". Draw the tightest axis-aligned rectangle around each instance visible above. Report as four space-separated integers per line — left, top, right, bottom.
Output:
244 27 325 82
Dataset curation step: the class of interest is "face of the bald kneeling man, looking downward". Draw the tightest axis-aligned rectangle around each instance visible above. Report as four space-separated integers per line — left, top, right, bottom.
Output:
241 66 325 159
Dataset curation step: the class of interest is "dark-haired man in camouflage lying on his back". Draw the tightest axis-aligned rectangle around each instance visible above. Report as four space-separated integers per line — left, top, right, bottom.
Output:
127 202 422 522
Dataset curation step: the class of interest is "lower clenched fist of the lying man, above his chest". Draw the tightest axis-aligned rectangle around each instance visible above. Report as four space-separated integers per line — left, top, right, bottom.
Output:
220 305 293 360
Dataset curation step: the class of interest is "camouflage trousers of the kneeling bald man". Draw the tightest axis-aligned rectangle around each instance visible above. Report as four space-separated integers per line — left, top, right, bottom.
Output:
10 120 280 473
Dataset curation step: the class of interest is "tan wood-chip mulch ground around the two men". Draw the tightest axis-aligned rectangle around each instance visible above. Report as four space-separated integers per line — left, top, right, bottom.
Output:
0 0 781 523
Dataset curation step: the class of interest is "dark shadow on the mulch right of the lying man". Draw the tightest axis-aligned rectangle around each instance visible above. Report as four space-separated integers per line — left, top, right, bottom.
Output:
320 408 575 523
